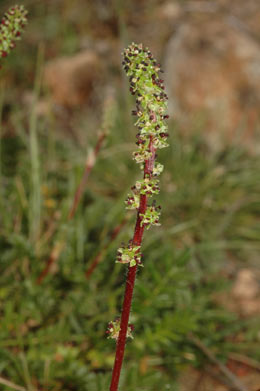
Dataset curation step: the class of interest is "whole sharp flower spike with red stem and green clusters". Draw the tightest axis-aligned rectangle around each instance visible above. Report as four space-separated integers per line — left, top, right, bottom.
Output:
107 43 169 391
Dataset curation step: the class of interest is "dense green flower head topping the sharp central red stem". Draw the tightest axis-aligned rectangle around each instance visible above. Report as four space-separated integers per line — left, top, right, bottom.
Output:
122 43 169 163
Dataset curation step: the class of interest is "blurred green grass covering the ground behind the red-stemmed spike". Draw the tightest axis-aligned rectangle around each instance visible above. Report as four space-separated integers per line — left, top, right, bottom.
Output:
0 78 260 391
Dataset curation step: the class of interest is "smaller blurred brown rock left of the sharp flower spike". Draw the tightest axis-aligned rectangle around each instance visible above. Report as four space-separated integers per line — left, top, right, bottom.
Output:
44 50 103 107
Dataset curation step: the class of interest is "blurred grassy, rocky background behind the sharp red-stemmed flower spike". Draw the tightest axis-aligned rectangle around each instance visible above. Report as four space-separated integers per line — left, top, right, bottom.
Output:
0 0 260 391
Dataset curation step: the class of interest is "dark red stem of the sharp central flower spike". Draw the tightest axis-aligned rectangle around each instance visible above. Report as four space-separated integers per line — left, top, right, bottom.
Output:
110 136 155 391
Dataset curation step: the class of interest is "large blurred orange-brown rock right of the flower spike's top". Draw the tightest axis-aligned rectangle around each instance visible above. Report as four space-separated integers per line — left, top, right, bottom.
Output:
164 15 260 148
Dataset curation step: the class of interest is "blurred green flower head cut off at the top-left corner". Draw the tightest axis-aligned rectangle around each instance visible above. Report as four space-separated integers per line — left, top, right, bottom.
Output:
0 5 27 58
